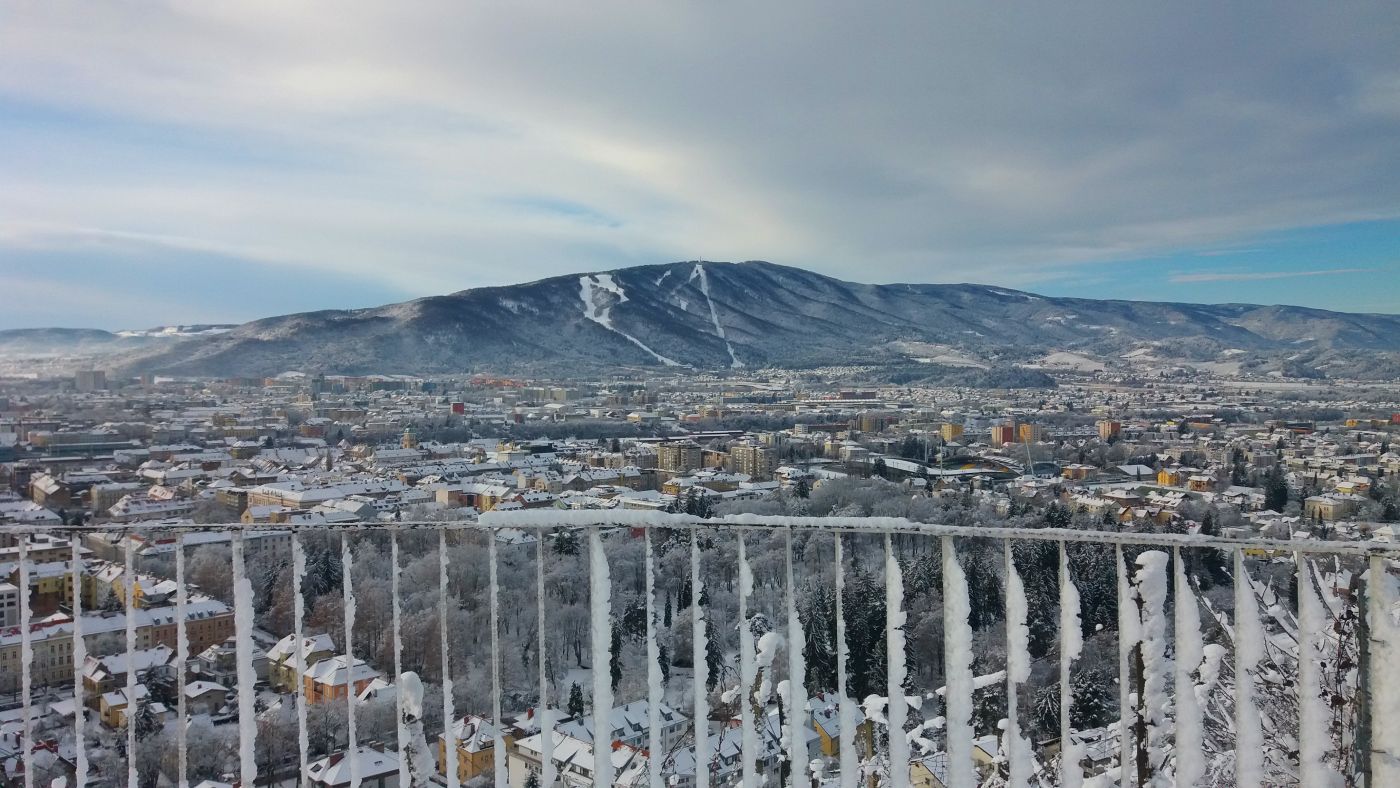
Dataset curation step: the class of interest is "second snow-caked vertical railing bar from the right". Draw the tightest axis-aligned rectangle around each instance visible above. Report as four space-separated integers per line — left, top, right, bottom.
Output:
1295 553 1344 788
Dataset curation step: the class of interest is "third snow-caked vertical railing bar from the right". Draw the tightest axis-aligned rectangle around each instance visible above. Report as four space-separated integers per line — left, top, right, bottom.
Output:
1235 550 1264 788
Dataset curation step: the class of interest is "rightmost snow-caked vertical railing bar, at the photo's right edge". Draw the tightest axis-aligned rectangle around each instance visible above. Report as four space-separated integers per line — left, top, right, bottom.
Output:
1366 554 1400 785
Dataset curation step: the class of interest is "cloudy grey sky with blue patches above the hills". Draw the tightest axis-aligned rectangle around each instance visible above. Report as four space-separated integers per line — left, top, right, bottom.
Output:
0 0 1400 329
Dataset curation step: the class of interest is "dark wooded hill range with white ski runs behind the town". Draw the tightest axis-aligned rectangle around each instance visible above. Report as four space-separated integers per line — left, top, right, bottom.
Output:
0 262 1400 385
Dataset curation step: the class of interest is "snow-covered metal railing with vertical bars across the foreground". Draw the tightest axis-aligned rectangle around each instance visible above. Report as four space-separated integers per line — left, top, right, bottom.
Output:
8 509 1400 788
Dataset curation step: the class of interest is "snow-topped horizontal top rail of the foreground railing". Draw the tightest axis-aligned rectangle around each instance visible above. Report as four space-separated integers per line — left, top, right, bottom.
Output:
0 509 1400 557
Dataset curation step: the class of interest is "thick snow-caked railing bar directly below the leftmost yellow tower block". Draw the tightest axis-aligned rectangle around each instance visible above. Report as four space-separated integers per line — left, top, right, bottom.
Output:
942 536 977 788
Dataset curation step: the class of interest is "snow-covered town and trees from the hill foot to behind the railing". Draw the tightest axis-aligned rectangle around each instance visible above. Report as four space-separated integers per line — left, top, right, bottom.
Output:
0 371 1400 788
